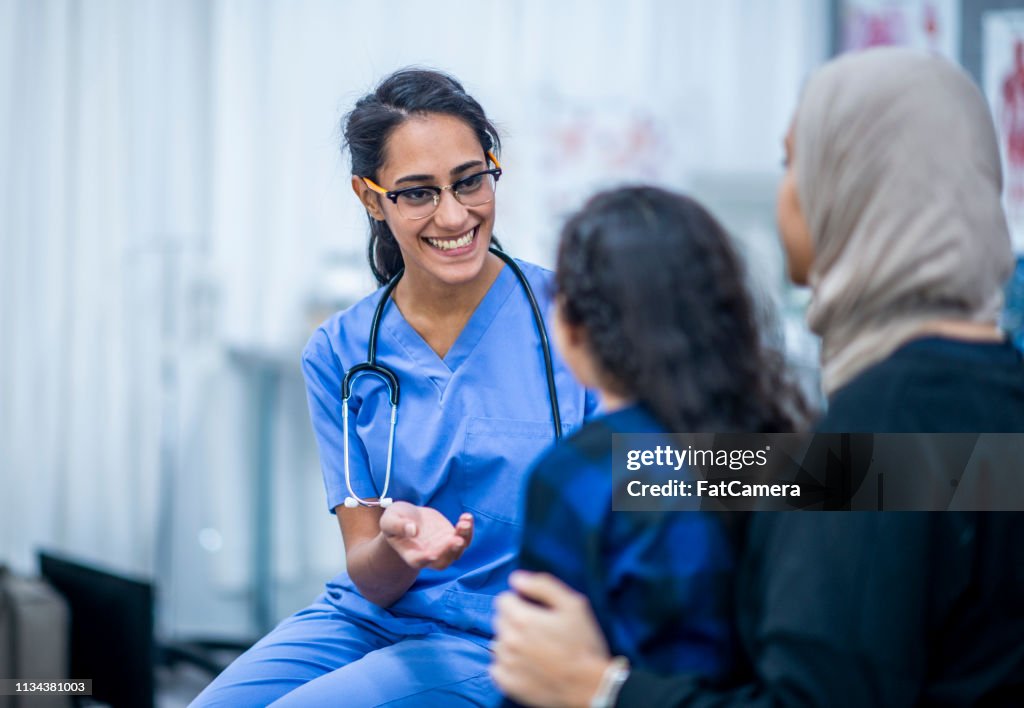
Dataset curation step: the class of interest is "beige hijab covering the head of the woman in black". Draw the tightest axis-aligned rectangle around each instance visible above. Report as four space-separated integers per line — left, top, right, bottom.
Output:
794 48 1013 394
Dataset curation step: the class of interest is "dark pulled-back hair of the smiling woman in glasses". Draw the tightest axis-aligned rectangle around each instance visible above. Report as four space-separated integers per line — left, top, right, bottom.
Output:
342 69 501 285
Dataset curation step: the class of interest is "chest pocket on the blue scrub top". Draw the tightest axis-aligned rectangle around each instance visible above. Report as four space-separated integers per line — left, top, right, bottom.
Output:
458 418 554 526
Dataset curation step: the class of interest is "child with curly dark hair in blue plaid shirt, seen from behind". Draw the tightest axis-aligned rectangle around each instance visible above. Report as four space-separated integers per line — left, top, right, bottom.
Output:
494 188 799 704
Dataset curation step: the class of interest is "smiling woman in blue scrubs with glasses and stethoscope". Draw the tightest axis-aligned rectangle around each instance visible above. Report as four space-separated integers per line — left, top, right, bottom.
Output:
195 70 594 706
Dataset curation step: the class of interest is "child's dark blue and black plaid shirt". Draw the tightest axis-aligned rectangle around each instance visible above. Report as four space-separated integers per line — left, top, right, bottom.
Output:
520 406 736 678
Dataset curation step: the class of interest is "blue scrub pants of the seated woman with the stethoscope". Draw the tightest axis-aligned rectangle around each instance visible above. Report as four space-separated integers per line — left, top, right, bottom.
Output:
190 598 501 708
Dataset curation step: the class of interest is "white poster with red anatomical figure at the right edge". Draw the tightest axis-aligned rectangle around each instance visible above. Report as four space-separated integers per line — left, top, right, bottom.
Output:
982 10 1024 253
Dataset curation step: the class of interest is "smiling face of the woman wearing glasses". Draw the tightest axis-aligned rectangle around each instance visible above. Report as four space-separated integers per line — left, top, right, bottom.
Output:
352 114 495 287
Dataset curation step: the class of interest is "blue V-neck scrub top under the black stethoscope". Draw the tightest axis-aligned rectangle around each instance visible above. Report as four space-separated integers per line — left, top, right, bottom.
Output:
302 261 597 637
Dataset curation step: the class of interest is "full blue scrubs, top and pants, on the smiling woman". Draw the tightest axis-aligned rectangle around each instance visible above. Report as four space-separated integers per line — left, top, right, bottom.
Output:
196 263 597 706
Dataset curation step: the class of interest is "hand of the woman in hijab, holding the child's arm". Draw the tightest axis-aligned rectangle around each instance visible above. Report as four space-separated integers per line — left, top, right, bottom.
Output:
490 571 611 708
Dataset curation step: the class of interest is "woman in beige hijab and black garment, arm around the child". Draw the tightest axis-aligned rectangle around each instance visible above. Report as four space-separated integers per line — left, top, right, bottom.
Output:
496 48 1024 708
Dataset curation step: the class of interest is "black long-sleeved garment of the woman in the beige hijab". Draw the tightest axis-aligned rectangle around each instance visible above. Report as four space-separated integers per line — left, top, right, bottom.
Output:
616 338 1024 708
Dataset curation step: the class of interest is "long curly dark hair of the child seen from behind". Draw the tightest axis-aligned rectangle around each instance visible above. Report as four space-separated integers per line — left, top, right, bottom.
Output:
555 186 806 432
